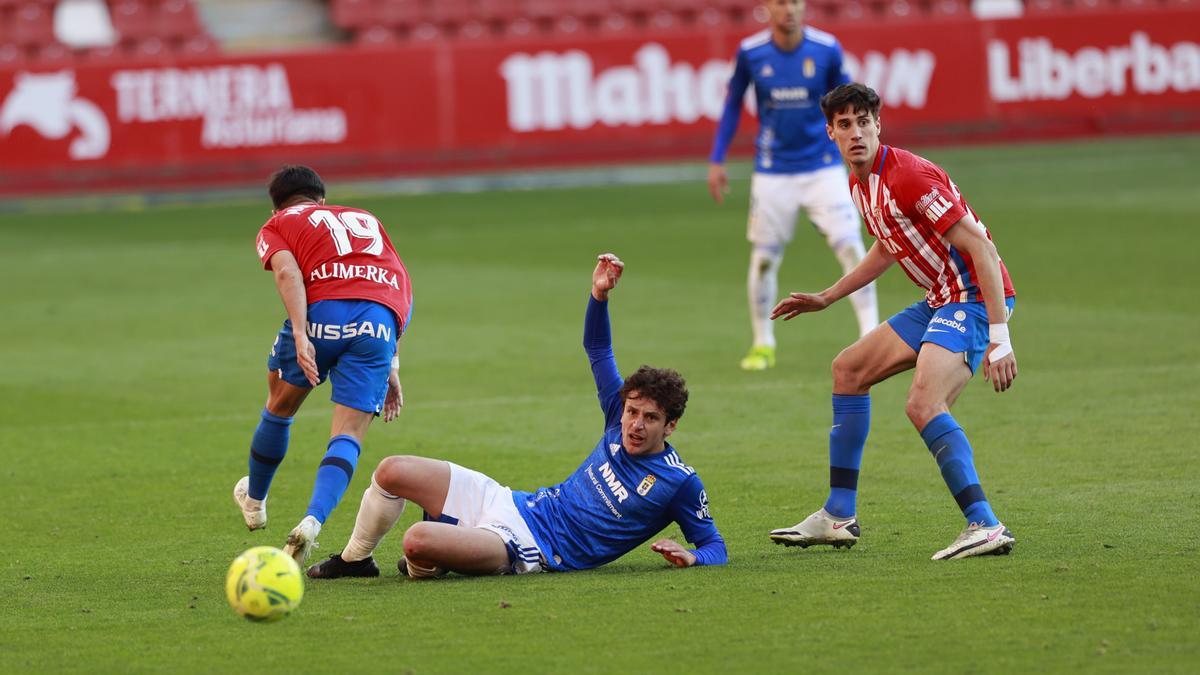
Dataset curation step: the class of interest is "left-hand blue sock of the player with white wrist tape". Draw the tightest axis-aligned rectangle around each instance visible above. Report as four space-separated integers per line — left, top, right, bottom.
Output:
824 394 871 518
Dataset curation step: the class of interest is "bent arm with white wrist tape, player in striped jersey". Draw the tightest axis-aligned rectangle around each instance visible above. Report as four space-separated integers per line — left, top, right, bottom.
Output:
944 218 1016 392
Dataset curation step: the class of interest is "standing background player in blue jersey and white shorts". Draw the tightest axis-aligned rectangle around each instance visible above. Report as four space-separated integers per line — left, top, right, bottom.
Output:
708 0 880 370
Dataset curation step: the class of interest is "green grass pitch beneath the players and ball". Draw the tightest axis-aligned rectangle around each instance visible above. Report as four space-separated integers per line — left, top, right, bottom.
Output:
0 133 1200 673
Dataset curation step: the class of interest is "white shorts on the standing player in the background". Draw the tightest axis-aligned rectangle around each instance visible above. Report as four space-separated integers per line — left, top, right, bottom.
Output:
746 165 863 247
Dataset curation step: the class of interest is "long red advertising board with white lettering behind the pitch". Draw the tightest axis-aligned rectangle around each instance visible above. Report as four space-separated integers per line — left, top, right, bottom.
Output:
0 10 1200 195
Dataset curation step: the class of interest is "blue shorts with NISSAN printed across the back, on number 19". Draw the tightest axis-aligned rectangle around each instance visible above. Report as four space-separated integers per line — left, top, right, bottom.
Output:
266 300 396 414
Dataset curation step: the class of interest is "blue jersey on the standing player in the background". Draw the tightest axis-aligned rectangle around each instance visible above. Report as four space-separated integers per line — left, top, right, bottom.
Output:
710 26 850 173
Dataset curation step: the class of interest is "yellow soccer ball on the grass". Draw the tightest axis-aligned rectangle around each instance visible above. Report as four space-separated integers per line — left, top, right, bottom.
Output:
226 546 304 621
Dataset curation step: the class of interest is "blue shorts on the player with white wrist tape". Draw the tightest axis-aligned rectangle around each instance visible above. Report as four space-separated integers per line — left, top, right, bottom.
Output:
888 298 1016 372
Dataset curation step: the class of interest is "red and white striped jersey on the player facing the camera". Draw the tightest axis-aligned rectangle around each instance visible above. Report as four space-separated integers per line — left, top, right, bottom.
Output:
850 145 1016 307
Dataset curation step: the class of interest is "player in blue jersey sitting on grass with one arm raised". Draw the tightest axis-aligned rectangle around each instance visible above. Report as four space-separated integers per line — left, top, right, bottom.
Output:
308 253 727 579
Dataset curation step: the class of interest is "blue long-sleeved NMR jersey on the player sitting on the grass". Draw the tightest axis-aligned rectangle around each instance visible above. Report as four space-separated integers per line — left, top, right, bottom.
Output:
512 299 725 571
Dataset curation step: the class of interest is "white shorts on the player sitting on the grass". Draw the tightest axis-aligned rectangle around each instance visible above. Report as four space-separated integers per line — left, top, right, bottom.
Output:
439 461 542 574
